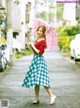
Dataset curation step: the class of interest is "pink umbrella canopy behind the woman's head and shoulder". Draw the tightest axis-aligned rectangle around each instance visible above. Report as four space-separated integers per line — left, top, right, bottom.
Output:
34 18 58 51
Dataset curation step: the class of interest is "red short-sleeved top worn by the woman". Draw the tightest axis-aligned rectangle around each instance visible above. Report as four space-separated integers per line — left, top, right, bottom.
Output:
34 40 46 55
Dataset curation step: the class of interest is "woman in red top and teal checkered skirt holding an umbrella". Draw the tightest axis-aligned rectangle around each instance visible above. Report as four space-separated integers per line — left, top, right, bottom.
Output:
22 25 56 104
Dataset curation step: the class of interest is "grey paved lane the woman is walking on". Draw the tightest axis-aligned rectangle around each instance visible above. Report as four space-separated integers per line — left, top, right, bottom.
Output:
0 52 80 108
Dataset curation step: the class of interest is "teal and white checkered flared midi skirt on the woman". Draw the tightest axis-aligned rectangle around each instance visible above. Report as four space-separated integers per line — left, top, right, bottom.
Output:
22 54 50 87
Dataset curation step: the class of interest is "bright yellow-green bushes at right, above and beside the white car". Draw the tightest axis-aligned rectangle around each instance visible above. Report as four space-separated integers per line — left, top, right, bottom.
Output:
56 25 80 52
